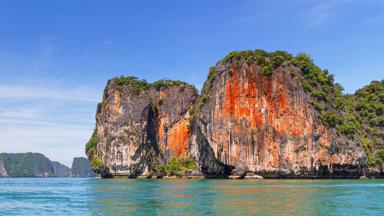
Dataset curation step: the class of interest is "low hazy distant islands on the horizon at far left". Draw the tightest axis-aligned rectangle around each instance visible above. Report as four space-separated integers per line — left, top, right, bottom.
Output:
0 153 96 178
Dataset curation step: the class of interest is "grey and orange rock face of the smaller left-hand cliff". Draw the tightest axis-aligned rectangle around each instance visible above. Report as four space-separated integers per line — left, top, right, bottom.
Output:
92 80 196 176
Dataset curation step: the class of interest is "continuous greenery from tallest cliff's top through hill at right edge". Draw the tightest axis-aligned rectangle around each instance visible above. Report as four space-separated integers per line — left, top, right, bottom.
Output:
204 50 384 166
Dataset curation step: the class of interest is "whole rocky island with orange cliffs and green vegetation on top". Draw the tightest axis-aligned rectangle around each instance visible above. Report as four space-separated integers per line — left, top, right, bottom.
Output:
86 50 384 178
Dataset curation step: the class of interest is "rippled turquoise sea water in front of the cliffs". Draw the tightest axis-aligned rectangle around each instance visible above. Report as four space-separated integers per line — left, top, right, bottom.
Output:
0 178 384 215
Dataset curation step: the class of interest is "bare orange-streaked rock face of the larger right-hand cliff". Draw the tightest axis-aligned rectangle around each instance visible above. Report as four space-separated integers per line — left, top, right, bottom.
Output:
192 62 366 177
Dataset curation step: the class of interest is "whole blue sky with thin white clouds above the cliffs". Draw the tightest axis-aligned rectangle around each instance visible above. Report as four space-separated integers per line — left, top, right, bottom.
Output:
0 0 384 166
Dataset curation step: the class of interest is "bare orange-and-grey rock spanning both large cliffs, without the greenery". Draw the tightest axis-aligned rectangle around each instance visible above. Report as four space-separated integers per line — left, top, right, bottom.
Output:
90 53 367 178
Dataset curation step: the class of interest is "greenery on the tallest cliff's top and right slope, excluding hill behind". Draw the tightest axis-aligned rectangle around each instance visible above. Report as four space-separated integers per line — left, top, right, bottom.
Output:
218 50 361 139
